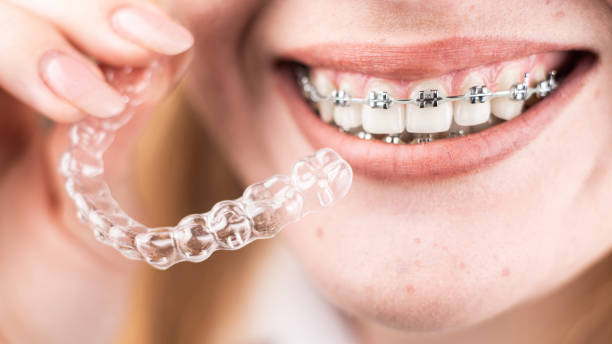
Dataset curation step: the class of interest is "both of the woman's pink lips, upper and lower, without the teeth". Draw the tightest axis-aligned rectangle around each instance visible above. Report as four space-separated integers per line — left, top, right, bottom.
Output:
278 38 593 180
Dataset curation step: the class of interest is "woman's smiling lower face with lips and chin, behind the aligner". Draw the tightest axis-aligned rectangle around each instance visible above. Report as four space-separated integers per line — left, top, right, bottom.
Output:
173 0 612 330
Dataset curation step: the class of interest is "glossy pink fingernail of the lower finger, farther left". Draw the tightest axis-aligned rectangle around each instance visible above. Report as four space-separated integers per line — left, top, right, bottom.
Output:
39 51 125 117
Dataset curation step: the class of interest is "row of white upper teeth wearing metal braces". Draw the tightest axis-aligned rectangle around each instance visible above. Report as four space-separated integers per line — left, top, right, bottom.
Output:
298 67 557 138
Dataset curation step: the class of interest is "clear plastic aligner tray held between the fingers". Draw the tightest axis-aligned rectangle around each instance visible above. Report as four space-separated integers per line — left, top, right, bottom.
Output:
60 62 353 269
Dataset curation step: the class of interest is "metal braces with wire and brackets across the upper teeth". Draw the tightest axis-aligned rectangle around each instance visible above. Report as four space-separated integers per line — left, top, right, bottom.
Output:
297 68 558 109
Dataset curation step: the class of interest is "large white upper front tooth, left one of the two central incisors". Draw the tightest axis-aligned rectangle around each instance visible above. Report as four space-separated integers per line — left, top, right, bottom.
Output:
361 83 406 134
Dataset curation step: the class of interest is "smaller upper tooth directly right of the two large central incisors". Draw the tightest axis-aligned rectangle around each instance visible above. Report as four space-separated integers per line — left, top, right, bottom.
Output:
453 74 491 126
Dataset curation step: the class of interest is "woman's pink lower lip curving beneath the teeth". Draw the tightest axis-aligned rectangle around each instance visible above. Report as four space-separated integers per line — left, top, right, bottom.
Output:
277 59 592 180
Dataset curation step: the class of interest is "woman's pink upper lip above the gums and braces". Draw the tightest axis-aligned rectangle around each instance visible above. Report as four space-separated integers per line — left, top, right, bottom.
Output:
281 37 580 80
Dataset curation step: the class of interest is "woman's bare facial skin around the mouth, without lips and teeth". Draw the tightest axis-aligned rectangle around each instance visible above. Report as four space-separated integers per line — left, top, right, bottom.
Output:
177 1 612 339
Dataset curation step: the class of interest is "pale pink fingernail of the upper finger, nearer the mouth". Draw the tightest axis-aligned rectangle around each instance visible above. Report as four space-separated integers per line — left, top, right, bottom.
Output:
111 7 193 55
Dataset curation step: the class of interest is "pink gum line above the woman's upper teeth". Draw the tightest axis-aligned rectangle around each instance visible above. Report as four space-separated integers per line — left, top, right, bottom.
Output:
311 52 568 98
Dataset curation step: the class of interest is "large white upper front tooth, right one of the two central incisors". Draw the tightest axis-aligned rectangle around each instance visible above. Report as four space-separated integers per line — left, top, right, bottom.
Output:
406 80 453 134
